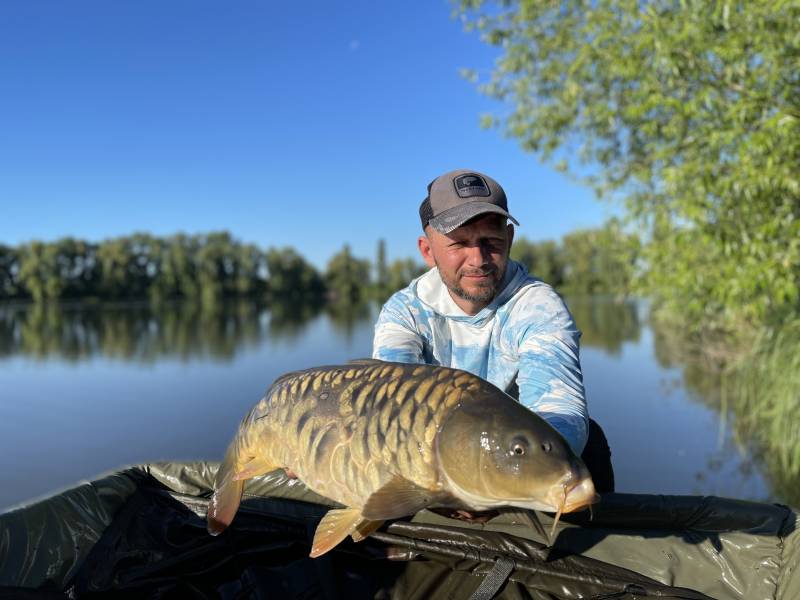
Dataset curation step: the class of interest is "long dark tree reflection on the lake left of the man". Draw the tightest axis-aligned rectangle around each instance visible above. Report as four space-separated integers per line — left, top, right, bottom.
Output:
0 301 330 362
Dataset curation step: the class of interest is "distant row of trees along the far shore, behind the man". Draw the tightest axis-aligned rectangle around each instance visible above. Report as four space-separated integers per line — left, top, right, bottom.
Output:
0 220 639 303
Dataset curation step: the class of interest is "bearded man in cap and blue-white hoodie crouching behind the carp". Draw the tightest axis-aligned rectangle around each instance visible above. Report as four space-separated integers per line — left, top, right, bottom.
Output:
373 169 613 491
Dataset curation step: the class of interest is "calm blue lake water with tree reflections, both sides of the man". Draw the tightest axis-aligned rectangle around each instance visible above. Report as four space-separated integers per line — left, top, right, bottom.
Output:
0 298 786 509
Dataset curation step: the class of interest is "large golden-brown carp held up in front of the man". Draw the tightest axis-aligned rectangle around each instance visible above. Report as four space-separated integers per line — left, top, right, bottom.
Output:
207 359 599 557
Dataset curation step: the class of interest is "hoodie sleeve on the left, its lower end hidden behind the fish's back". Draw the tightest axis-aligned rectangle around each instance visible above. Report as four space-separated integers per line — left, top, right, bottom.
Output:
372 292 425 363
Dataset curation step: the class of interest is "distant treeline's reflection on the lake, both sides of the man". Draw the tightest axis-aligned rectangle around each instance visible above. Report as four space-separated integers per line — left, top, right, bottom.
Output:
0 298 641 363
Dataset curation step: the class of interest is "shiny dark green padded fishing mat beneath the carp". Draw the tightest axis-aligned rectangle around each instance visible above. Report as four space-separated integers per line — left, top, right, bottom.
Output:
0 462 800 600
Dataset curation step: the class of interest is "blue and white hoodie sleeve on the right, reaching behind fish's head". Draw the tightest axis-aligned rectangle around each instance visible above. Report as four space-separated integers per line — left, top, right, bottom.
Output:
517 289 589 456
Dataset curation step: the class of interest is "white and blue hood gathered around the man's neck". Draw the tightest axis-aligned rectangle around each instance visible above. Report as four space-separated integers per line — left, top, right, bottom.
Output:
412 259 528 325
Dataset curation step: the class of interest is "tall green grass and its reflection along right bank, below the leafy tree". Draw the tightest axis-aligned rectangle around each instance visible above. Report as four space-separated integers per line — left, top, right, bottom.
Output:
653 323 800 506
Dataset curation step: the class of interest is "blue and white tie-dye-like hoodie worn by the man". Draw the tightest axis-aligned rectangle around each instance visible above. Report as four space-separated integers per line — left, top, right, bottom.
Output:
372 260 588 455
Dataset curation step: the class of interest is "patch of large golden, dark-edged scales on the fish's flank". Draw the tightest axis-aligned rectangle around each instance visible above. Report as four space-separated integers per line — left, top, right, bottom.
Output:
247 364 463 500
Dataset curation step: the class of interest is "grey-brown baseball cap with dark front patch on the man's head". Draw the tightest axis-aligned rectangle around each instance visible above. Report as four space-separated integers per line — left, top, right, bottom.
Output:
419 169 519 234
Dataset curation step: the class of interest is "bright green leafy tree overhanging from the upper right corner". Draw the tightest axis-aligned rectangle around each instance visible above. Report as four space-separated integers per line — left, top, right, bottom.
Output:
460 0 800 330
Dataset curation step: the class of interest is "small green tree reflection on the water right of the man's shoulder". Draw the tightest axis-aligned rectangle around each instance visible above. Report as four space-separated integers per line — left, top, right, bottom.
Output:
567 296 641 354
